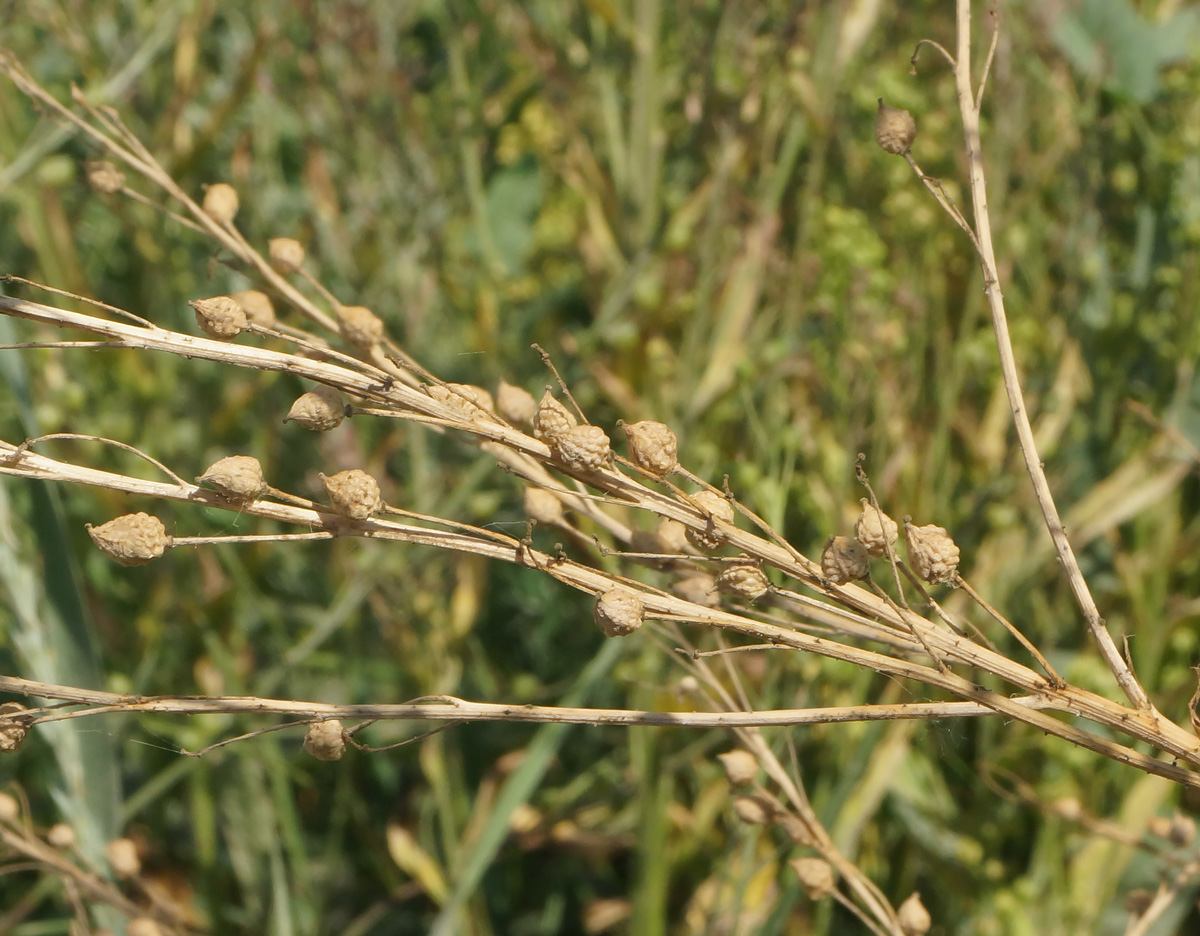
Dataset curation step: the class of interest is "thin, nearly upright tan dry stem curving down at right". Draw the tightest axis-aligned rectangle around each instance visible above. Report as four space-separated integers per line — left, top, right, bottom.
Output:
954 0 1152 712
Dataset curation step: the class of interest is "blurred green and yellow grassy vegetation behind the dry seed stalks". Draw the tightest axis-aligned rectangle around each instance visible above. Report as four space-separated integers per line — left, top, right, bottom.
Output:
0 0 1200 936
